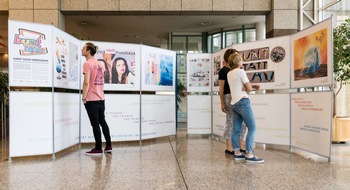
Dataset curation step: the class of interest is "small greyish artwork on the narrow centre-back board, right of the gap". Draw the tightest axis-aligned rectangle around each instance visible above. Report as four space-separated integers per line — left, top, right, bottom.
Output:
187 58 210 87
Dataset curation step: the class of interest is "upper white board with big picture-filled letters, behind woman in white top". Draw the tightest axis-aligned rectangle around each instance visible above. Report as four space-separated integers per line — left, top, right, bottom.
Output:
233 36 290 89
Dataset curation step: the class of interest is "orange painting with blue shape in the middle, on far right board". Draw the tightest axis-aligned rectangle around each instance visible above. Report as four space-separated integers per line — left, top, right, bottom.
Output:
294 28 328 81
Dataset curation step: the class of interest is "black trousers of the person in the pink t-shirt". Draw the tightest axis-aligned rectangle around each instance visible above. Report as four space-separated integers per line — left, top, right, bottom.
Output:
84 100 112 150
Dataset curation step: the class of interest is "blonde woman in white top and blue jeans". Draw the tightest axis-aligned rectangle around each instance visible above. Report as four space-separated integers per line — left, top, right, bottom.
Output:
227 54 264 163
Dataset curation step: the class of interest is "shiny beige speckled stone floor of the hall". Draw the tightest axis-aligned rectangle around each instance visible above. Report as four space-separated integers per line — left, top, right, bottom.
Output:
0 128 350 190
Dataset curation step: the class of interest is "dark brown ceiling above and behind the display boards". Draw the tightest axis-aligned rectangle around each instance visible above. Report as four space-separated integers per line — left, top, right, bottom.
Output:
0 15 265 53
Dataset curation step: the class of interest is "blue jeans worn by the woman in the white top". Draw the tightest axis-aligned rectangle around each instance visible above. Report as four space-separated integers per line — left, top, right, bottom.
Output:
231 98 256 153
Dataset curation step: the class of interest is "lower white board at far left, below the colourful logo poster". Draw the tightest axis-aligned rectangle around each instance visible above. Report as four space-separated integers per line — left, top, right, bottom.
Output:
9 91 53 157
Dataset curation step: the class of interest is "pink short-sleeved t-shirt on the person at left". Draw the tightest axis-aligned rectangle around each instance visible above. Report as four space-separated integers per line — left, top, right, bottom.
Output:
83 58 105 101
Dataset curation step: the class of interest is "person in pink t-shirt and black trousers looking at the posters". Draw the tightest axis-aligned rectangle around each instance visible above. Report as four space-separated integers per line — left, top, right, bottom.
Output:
81 43 112 155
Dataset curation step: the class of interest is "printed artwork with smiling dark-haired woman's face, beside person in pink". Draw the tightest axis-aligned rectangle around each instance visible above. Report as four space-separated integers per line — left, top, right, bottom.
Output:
95 48 136 85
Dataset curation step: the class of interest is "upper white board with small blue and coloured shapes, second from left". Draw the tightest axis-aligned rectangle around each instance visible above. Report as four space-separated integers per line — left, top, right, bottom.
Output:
51 27 81 89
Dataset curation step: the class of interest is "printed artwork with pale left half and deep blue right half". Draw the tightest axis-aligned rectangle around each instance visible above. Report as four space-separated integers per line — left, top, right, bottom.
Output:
144 53 174 86
